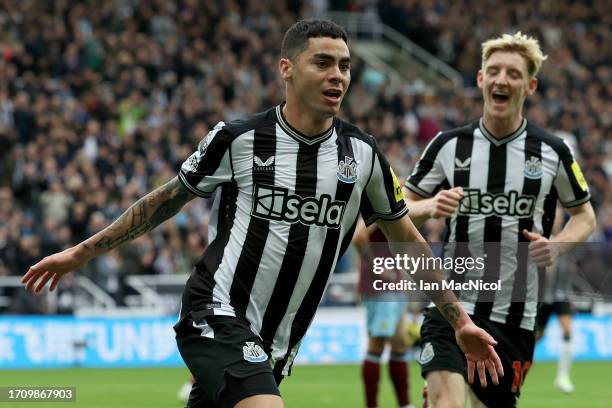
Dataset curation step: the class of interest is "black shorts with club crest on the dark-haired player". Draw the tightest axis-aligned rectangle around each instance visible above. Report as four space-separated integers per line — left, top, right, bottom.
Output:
174 312 281 408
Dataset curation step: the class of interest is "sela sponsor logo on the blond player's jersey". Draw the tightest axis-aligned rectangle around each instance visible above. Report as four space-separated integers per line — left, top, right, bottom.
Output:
458 189 536 218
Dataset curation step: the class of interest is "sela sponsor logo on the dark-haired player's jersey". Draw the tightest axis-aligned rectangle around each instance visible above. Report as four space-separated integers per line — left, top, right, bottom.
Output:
251 184 346 229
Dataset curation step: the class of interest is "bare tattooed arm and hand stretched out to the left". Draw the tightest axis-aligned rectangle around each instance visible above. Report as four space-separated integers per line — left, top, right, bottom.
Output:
21 177 195 293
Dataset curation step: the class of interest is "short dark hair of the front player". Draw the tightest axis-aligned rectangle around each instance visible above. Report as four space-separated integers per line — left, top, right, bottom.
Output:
281 19 348 59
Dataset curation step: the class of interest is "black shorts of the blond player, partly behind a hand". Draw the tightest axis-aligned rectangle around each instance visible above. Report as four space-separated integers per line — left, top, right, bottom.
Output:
419 308 535 408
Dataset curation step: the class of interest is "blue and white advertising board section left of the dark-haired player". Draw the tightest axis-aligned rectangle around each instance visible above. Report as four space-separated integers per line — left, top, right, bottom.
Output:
0 316 183 369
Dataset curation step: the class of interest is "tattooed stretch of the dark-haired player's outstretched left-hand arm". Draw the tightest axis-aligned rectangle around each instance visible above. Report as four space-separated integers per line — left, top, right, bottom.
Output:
91 177 195 250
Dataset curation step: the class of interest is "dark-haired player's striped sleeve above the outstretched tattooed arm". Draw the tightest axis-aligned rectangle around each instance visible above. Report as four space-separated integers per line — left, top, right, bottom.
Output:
179 122 233 197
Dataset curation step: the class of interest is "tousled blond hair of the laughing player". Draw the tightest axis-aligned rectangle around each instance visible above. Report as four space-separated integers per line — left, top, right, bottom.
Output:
482 31 548 78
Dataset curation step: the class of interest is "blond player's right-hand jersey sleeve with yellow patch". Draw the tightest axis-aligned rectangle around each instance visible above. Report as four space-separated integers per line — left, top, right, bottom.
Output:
554 143 591 208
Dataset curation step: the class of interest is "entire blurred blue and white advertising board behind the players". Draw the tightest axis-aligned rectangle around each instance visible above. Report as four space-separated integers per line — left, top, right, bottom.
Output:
0 307 612 369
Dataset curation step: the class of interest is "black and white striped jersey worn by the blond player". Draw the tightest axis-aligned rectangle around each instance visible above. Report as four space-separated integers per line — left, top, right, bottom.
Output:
406 119 590 330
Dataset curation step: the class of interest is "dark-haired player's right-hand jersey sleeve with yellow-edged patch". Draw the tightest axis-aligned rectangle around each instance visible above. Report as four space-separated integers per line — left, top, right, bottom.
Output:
361 147 408 225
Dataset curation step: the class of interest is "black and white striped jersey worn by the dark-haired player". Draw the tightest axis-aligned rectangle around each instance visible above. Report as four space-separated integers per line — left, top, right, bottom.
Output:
179 106 408 375
